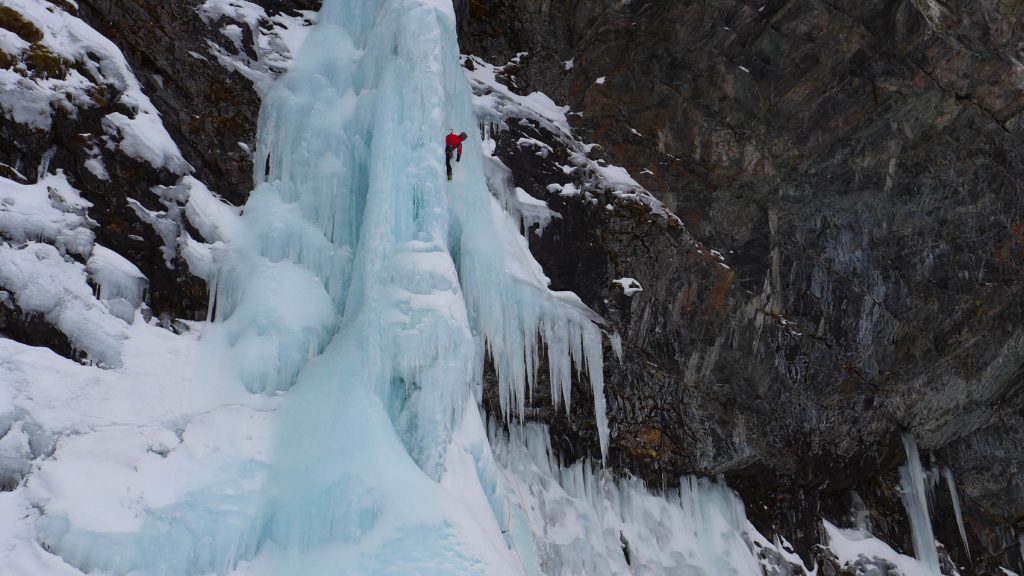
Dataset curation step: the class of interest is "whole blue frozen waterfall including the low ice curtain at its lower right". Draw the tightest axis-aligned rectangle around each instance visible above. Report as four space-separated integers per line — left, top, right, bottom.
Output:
25 0 770 576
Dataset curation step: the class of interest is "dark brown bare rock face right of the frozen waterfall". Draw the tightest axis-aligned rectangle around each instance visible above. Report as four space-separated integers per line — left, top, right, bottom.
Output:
456 0 1024 573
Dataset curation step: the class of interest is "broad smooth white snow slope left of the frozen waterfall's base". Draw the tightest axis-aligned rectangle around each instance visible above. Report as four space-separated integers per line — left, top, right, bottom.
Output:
0 322 276 575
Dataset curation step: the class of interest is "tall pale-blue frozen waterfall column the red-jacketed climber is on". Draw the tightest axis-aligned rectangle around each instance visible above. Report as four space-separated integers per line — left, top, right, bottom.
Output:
215 0 607 574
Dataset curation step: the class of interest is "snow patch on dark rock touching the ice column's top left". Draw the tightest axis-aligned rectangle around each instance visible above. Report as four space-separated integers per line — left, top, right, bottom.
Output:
198 0 316 95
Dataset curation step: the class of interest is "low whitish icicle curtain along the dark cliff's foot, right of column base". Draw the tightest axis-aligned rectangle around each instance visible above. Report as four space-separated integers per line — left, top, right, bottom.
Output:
488 416 767 576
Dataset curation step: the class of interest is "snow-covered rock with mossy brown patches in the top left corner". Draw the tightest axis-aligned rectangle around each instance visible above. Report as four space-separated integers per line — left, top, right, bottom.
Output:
0 0 191 174
